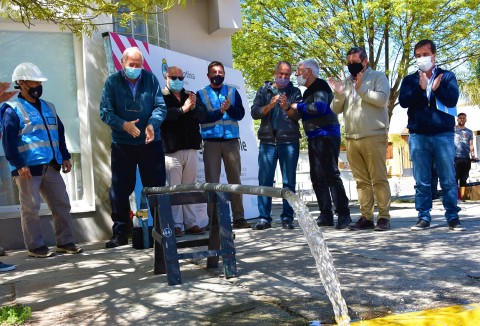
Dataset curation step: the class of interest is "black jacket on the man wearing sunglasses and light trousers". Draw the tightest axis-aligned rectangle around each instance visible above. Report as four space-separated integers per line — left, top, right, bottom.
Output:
161 88 207 153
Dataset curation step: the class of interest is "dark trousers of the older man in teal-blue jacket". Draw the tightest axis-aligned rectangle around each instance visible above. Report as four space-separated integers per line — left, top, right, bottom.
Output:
110 141 165 236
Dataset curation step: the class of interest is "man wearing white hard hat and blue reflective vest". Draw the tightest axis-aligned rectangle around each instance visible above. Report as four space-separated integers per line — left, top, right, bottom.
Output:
0 62 82 258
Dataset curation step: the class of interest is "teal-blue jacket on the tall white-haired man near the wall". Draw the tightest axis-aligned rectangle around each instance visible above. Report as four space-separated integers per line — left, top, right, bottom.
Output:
100 69 167 145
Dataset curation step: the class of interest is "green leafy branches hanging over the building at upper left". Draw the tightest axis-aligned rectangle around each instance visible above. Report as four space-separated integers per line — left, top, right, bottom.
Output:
0 0 186 35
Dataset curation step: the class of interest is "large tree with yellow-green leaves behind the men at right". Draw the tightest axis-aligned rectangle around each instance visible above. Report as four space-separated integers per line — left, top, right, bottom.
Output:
233 0 480 116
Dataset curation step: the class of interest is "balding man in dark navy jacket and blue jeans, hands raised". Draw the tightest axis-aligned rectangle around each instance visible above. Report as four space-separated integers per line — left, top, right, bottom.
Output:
251 61 302 230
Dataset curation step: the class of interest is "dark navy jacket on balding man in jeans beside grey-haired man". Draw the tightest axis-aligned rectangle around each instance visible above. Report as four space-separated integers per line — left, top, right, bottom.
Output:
250 81 302 143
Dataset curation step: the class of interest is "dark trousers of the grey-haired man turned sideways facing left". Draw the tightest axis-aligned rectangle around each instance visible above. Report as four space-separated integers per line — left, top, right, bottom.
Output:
308 136 350 217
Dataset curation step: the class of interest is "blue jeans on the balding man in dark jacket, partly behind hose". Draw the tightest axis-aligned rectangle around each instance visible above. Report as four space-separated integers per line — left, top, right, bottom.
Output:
258 143 300 223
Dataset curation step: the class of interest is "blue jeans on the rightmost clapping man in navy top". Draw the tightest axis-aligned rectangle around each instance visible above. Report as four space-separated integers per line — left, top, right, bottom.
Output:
409 131 460 222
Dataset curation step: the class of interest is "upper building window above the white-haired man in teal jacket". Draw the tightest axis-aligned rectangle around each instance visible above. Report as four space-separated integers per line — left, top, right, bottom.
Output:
114 7 170 49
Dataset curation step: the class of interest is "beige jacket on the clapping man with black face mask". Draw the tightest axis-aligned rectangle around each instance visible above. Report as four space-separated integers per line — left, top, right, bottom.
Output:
332 67 390 139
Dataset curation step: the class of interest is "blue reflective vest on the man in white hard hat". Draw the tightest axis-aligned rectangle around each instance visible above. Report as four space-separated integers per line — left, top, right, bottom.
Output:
6 98 63 171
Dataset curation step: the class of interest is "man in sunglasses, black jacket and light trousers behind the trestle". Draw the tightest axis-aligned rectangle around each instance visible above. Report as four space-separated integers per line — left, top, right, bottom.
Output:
161 66 207 237
